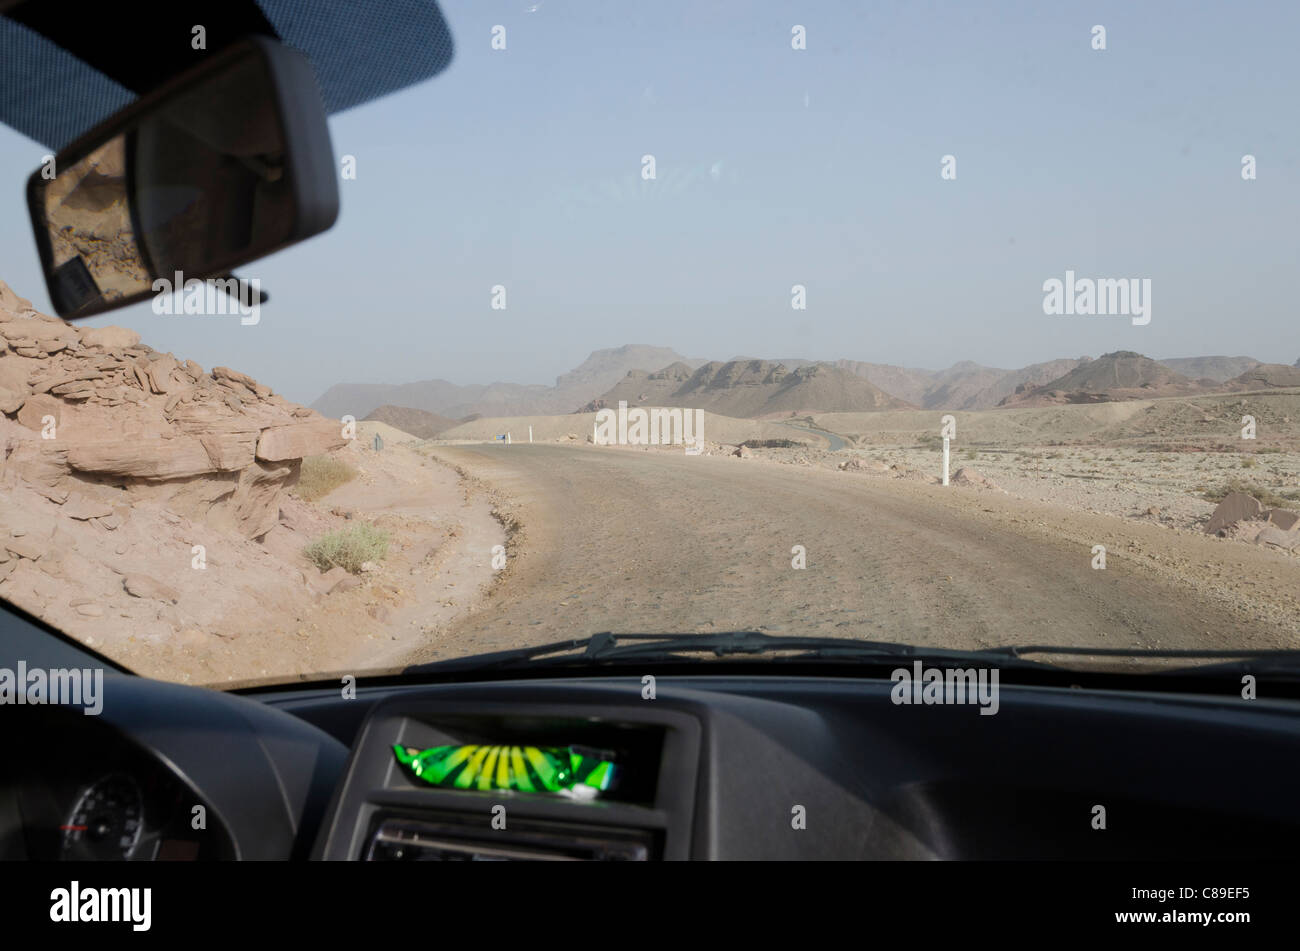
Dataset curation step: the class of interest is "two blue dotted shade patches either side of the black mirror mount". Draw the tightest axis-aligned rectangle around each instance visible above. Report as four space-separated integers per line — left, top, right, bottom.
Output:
0 0 452 151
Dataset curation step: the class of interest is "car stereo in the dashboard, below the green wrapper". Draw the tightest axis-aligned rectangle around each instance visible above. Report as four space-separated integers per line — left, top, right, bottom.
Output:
365 816 653 861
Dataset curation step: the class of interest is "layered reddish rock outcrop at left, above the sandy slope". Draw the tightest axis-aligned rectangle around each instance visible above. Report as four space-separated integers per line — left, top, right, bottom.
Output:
0 282 346 538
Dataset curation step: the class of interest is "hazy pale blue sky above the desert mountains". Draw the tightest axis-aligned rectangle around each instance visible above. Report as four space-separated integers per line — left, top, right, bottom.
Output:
0 0 1300 401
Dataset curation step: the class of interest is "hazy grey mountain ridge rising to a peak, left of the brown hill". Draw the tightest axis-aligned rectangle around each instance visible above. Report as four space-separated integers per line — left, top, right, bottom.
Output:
312 344 703 418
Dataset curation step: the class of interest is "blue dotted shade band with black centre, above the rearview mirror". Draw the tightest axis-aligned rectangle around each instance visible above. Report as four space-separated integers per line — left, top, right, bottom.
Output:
0 0 452 151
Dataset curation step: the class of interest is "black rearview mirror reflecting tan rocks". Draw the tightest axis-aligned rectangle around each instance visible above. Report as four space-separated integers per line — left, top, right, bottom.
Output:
27 36 338 317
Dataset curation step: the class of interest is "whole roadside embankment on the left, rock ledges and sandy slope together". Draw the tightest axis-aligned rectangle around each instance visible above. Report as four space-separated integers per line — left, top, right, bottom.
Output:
0 271 504 685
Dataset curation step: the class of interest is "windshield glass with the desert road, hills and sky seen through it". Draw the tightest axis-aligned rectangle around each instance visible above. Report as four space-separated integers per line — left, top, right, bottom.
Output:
0 0 1300 686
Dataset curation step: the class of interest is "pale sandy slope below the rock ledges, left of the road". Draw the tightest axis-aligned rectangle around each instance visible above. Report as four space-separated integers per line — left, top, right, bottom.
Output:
41 424 506 687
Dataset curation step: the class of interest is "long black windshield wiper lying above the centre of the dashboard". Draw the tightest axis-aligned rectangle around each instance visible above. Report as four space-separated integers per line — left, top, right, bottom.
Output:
404 630 1052 674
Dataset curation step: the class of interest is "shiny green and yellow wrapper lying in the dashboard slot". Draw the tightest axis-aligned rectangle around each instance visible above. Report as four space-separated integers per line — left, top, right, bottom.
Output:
393 746 618 799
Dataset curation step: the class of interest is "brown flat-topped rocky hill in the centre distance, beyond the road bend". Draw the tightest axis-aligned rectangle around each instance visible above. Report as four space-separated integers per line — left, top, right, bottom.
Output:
577 360 909 418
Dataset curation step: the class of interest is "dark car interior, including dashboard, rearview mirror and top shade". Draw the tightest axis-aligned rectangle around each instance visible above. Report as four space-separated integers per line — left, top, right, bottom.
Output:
0 0 1300 899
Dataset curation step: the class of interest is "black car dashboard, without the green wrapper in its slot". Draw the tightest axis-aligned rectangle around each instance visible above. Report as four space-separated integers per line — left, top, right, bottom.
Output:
0 670 1300 861
